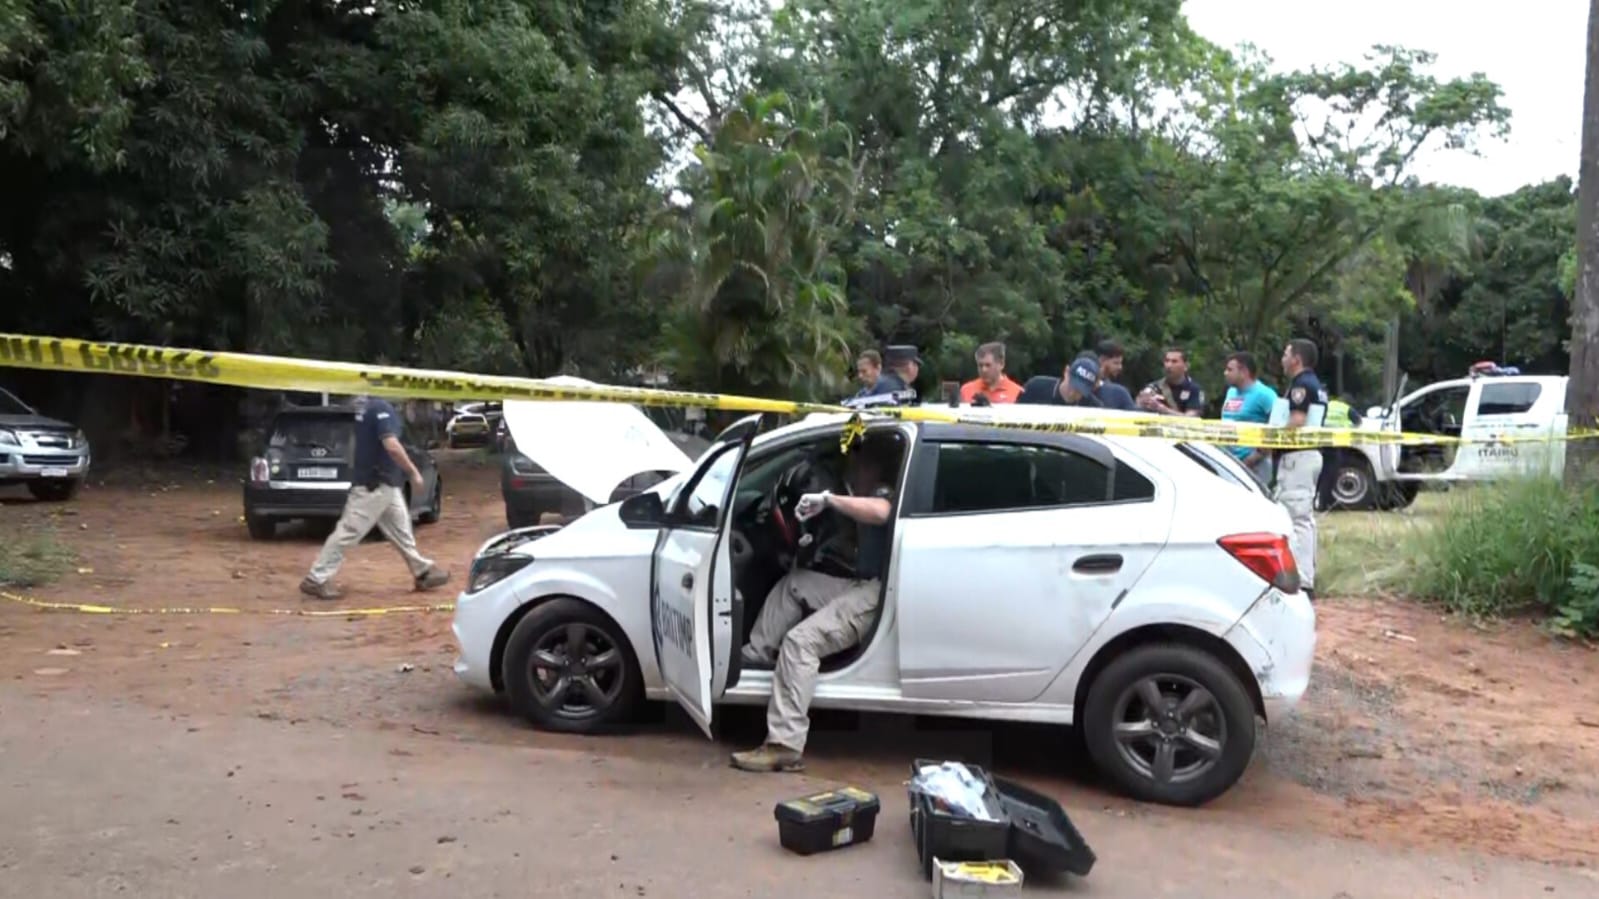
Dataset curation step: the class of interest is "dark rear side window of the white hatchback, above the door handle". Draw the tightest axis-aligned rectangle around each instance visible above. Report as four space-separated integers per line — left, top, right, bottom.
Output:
931 443 1154 515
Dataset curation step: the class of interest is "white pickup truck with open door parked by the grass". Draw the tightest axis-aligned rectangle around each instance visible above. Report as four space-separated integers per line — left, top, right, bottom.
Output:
1319 367 1567 509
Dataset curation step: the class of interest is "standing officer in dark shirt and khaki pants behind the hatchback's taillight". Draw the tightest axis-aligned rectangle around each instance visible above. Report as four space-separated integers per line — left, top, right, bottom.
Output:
1276 338 1327 598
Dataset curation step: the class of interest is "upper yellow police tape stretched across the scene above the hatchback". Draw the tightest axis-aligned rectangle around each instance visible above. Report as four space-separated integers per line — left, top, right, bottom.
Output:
0 333 1599 450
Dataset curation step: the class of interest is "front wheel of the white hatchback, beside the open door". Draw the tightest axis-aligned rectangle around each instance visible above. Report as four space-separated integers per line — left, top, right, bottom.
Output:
500 600 643 734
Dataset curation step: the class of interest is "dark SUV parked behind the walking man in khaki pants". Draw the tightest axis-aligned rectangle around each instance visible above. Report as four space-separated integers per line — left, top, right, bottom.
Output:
245 406 445 539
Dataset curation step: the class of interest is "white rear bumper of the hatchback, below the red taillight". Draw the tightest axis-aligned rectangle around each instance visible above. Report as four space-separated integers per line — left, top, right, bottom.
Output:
1223 590 1316 721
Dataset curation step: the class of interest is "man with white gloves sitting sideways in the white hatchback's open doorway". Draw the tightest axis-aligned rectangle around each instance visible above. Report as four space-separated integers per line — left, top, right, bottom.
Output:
732 443 894 771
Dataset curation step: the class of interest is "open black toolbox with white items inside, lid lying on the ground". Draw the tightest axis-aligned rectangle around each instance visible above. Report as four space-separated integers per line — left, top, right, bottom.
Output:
908 758 1095 878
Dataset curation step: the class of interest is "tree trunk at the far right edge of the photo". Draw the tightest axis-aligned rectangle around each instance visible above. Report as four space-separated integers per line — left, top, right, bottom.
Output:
1565 0 1599 483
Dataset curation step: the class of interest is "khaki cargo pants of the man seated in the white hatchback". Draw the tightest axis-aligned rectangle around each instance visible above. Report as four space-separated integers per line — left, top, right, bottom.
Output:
750 568 883 753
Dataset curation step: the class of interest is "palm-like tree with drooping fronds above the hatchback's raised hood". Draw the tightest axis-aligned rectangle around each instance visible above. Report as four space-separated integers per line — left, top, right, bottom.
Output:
667 93 857 398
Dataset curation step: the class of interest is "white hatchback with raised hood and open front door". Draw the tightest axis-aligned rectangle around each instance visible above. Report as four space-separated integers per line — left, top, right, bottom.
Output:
454 406 1316 805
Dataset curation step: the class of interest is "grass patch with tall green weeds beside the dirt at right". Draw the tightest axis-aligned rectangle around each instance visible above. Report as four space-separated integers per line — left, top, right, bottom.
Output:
1316 478 1599 637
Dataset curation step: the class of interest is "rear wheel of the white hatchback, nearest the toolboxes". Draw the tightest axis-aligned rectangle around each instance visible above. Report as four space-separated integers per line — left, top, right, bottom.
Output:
1081 643 1255 806
